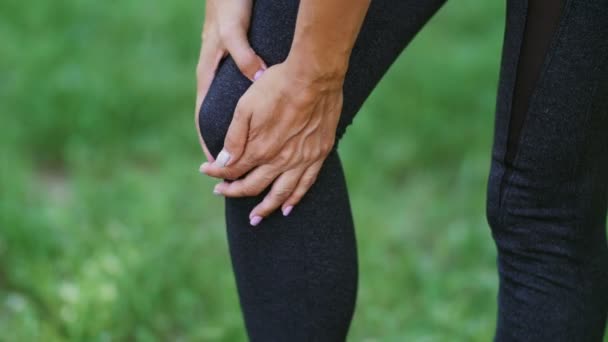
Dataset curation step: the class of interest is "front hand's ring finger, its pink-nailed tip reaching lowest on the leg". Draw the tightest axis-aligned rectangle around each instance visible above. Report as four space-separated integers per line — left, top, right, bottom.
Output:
249 168 304 226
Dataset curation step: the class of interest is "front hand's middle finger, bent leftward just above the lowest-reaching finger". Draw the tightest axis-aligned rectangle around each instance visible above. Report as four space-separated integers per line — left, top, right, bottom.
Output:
213 164 280 197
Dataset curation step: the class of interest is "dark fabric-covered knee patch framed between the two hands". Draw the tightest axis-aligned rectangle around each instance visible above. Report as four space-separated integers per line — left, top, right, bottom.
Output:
197 57 251 157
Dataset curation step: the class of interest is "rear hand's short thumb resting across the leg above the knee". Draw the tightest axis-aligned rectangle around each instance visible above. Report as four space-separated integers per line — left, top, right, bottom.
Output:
224 30 267 81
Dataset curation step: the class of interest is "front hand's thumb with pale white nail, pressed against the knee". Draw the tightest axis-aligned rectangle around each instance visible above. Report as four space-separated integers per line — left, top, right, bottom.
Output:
216 96 251 166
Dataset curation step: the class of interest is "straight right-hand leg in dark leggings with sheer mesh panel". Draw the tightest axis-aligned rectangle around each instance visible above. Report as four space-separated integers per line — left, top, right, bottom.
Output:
487 0 608 341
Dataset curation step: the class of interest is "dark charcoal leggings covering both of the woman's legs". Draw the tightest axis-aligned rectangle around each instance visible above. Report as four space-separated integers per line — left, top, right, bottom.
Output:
199 0 608 341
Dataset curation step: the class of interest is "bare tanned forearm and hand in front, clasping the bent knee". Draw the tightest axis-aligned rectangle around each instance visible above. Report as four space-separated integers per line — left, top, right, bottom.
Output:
200 0 370 225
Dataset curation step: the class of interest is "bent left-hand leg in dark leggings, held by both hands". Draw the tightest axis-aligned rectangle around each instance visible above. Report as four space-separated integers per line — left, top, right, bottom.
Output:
199 0 444 342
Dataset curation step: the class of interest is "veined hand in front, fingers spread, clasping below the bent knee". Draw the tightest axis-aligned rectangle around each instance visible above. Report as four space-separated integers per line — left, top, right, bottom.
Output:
201 57 346 225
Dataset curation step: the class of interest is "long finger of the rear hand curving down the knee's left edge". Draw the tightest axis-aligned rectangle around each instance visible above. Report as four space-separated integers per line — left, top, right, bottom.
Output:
194 37 225 161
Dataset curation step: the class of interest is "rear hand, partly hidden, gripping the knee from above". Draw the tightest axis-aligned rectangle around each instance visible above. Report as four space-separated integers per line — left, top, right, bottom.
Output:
194 0 266 161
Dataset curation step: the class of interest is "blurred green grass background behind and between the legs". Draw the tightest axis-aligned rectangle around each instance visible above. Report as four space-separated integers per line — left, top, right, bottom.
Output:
0 0 504 341
